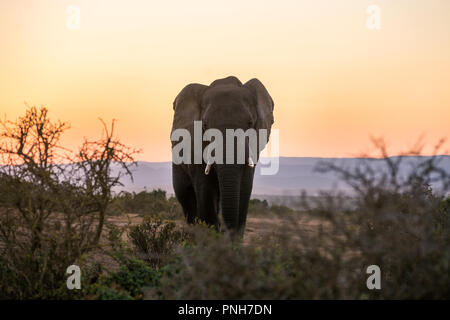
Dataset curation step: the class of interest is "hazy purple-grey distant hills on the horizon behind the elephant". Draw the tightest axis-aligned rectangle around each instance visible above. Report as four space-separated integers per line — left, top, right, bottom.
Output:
115 156 450 196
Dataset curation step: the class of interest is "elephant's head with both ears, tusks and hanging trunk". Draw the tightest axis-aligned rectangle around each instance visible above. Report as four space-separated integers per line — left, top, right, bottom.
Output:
172 76 274 229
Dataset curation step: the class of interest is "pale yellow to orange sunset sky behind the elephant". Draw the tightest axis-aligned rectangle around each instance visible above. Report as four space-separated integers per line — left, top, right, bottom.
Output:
0 0 450 161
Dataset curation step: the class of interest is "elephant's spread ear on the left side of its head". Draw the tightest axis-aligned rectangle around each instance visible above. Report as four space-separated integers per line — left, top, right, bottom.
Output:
172 83 208 144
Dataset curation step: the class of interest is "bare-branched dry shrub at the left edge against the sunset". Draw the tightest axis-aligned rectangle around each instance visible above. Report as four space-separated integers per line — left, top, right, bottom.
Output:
0 107 135 299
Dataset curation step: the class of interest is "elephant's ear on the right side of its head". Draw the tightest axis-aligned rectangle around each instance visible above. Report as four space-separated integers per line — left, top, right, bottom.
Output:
244 79 274 146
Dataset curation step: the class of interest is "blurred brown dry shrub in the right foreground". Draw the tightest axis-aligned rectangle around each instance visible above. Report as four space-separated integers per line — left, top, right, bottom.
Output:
146 141 450 299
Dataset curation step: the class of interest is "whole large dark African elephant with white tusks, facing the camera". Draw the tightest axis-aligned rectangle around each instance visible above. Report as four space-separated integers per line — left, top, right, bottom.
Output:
171 76 274 235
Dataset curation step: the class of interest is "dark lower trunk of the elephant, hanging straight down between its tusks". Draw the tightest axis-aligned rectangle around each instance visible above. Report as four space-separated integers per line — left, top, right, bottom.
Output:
217 164 242 231
